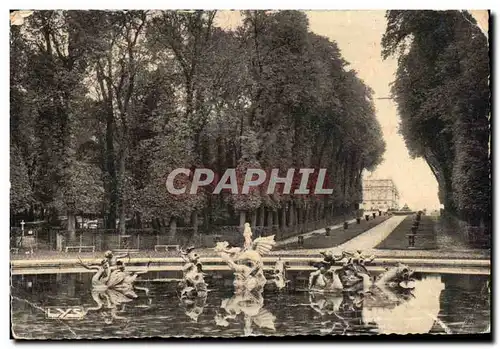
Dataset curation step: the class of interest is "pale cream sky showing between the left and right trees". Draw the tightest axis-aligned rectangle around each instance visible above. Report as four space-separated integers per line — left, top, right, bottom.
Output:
218 10 487 209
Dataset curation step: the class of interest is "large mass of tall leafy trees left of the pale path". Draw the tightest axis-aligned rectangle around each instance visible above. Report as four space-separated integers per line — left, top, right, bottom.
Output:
10 11 385 239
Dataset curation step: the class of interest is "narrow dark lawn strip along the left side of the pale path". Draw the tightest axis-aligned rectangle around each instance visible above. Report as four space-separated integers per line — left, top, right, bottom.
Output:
275 216 389 250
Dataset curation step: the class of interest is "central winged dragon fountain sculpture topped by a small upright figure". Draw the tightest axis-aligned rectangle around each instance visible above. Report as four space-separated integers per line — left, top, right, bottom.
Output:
214 223 276 291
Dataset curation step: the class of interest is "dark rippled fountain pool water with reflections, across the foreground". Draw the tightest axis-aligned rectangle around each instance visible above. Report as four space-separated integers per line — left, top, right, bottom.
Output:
11 270 490 339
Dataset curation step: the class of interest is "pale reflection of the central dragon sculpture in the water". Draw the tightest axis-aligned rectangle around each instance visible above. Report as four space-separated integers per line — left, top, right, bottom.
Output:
215 291 276 336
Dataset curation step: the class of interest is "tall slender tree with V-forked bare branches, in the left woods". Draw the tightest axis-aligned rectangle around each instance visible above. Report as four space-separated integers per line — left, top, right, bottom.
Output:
87 11 148 234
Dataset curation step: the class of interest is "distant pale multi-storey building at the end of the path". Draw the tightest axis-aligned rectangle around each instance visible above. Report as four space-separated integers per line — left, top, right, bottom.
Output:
363 179 399 211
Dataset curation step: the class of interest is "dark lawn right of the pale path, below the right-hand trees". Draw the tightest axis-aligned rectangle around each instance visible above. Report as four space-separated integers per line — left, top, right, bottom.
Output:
375 215 437 250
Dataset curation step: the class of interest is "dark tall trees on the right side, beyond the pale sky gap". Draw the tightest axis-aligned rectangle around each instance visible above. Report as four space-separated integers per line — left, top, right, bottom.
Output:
382 11 491 234
